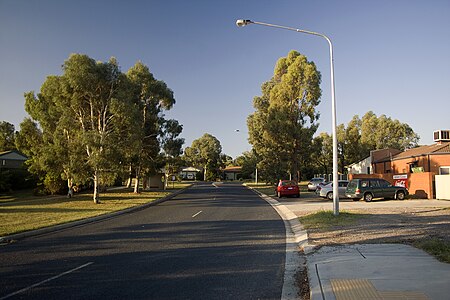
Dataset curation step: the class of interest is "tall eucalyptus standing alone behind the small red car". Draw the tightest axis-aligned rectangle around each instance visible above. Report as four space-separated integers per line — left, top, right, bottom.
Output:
247 51 321 181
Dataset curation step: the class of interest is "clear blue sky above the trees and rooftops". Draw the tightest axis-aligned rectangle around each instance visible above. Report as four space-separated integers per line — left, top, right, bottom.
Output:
0 0 450 157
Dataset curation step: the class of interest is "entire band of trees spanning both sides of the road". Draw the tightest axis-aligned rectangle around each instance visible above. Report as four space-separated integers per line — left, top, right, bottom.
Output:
0 51 419 191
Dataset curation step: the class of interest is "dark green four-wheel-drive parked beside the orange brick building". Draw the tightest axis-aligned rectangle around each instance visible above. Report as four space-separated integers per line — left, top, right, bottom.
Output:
345 178 408 202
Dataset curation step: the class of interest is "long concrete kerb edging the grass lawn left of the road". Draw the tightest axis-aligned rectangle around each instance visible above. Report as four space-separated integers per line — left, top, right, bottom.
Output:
0 185 192 243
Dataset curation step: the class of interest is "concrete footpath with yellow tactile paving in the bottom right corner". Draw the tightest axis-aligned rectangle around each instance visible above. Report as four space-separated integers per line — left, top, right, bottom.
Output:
307 244 450 300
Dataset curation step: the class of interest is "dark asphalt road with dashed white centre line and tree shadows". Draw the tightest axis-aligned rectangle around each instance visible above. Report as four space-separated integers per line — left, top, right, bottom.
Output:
0 184 286 300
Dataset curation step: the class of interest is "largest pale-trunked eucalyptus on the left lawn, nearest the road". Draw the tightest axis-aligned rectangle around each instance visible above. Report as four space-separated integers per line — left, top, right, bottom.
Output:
25 54 137 203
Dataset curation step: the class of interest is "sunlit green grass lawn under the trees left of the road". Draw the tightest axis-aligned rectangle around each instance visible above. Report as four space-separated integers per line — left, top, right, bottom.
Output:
0 184 188 236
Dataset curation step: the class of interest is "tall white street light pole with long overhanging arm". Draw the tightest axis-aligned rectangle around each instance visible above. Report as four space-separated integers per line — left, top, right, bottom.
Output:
236 20 339 216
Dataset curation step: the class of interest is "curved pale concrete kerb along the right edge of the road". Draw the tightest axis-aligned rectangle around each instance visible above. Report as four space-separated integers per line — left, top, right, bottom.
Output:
247 186 313 299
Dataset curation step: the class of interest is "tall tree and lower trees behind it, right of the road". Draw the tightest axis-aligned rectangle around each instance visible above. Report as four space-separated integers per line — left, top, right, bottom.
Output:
236 51 419 183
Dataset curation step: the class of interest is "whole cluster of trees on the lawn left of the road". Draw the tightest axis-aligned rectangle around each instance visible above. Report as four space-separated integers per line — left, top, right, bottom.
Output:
2 54 184 203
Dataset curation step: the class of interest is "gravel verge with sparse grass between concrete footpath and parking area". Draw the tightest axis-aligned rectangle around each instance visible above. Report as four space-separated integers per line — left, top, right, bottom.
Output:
297 207 450 246
